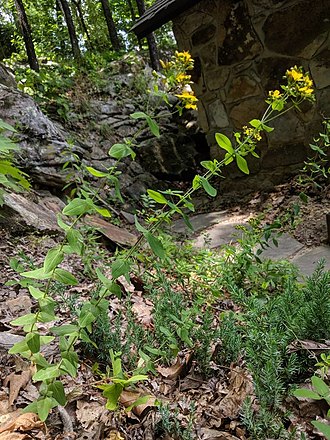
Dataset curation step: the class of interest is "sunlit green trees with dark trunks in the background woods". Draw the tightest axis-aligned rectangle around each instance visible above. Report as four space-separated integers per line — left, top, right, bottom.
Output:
0 0 174 71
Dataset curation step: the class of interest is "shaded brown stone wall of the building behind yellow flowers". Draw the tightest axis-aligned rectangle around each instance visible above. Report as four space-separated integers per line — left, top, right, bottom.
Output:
174 0 330 192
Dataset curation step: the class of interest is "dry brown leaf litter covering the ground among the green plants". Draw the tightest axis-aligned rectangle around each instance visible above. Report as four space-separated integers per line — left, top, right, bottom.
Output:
0 182 329 440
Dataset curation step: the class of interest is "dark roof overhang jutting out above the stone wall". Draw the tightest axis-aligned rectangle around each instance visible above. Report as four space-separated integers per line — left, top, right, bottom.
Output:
131 0 201 38
